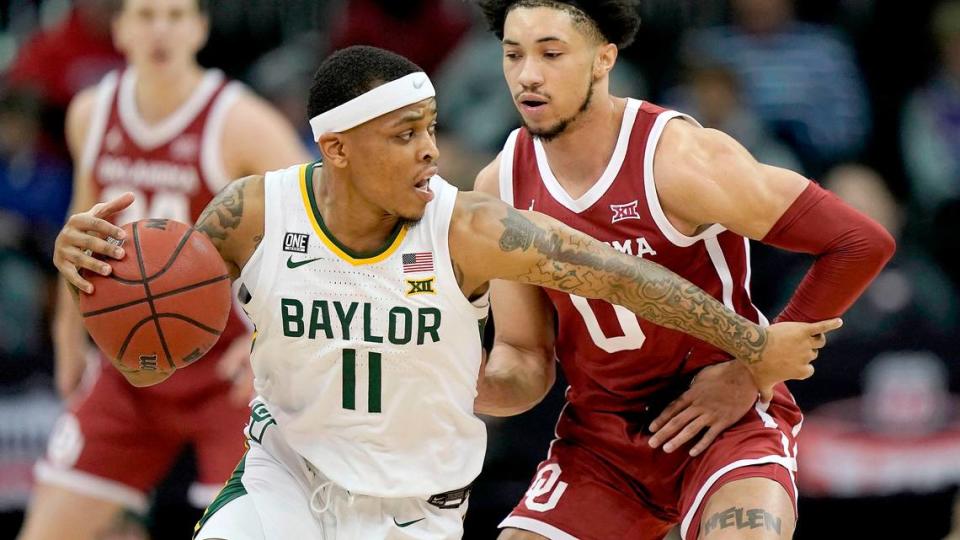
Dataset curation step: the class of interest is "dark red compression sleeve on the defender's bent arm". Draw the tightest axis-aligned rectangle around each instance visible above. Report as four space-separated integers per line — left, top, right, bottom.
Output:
763 182 895 322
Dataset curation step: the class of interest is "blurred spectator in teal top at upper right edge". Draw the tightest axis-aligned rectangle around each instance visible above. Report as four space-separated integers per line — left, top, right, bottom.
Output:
901 0 960 211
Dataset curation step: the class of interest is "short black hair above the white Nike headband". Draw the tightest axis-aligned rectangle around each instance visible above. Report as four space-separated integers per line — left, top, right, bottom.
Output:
307 45 423 118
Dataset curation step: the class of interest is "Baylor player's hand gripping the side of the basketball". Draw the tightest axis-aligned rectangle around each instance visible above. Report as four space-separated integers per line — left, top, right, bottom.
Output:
53 192 133 294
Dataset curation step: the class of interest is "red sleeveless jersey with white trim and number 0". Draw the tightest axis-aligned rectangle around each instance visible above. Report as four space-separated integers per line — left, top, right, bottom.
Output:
500 99 766 414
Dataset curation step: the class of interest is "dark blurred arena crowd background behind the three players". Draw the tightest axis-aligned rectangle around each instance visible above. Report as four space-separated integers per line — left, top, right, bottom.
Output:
0 0 960 539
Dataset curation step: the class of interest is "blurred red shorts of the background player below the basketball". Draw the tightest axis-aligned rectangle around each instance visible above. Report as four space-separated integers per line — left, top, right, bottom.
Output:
35 358 250 510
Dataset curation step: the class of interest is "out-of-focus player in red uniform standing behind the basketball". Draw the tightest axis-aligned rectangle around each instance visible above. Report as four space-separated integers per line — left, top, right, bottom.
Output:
20 0 309 540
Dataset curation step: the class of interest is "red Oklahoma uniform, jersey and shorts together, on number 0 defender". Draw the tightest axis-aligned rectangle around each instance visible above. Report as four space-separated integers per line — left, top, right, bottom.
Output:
500 99 802 540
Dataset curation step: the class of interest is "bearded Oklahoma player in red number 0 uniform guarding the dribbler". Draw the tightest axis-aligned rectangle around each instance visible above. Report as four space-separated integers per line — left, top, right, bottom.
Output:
477 0 894 540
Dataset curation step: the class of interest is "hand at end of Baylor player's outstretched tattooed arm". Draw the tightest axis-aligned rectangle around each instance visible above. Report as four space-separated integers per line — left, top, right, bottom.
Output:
747 319 843 401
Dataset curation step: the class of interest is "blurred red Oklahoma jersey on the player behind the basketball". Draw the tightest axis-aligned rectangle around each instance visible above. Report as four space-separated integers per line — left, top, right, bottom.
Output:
80 68 247 395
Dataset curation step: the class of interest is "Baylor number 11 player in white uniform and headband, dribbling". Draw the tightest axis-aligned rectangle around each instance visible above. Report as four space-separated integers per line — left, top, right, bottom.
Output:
55 47 839 540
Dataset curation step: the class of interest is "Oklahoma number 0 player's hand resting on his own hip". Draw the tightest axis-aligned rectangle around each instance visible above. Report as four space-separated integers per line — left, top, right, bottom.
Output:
648 360 758 456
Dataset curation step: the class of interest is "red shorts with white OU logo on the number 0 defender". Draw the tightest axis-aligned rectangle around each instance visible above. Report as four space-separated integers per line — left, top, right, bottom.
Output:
500 385 802 540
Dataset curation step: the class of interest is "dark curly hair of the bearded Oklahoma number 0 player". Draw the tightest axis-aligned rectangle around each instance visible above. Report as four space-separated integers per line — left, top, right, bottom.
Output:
478 0 640 49
